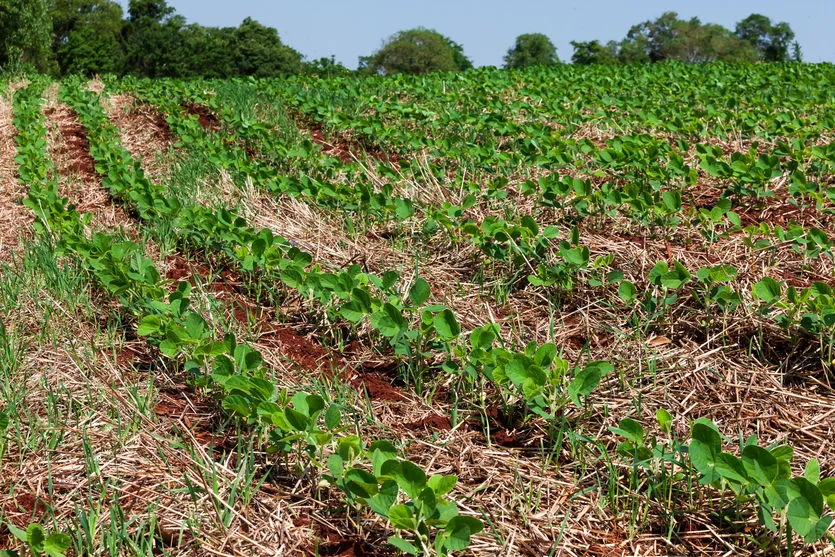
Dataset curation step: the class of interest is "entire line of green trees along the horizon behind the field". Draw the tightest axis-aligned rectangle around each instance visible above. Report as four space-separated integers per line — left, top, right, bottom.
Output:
0 0 802 78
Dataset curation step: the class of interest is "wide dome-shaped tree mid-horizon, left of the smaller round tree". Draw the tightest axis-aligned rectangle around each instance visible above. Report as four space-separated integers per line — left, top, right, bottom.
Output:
360 27 472 75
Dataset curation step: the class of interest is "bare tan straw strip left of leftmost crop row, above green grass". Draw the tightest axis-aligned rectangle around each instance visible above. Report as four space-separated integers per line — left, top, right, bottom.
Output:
0 100 32 261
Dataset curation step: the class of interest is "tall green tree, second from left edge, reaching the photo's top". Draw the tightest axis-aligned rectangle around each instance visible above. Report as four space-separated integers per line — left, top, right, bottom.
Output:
51 0 123 75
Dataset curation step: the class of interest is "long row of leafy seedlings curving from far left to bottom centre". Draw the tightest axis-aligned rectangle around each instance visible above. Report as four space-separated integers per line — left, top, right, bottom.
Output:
14 80 482 555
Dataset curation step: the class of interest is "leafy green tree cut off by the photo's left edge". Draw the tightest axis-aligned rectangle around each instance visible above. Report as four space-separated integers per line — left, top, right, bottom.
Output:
0 0 55 73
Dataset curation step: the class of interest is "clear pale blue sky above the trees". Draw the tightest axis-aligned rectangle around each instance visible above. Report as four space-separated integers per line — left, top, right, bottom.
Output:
114 0 835 68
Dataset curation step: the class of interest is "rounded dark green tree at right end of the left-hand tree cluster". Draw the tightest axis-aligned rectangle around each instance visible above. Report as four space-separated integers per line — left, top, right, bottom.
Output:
232 17 302 77
